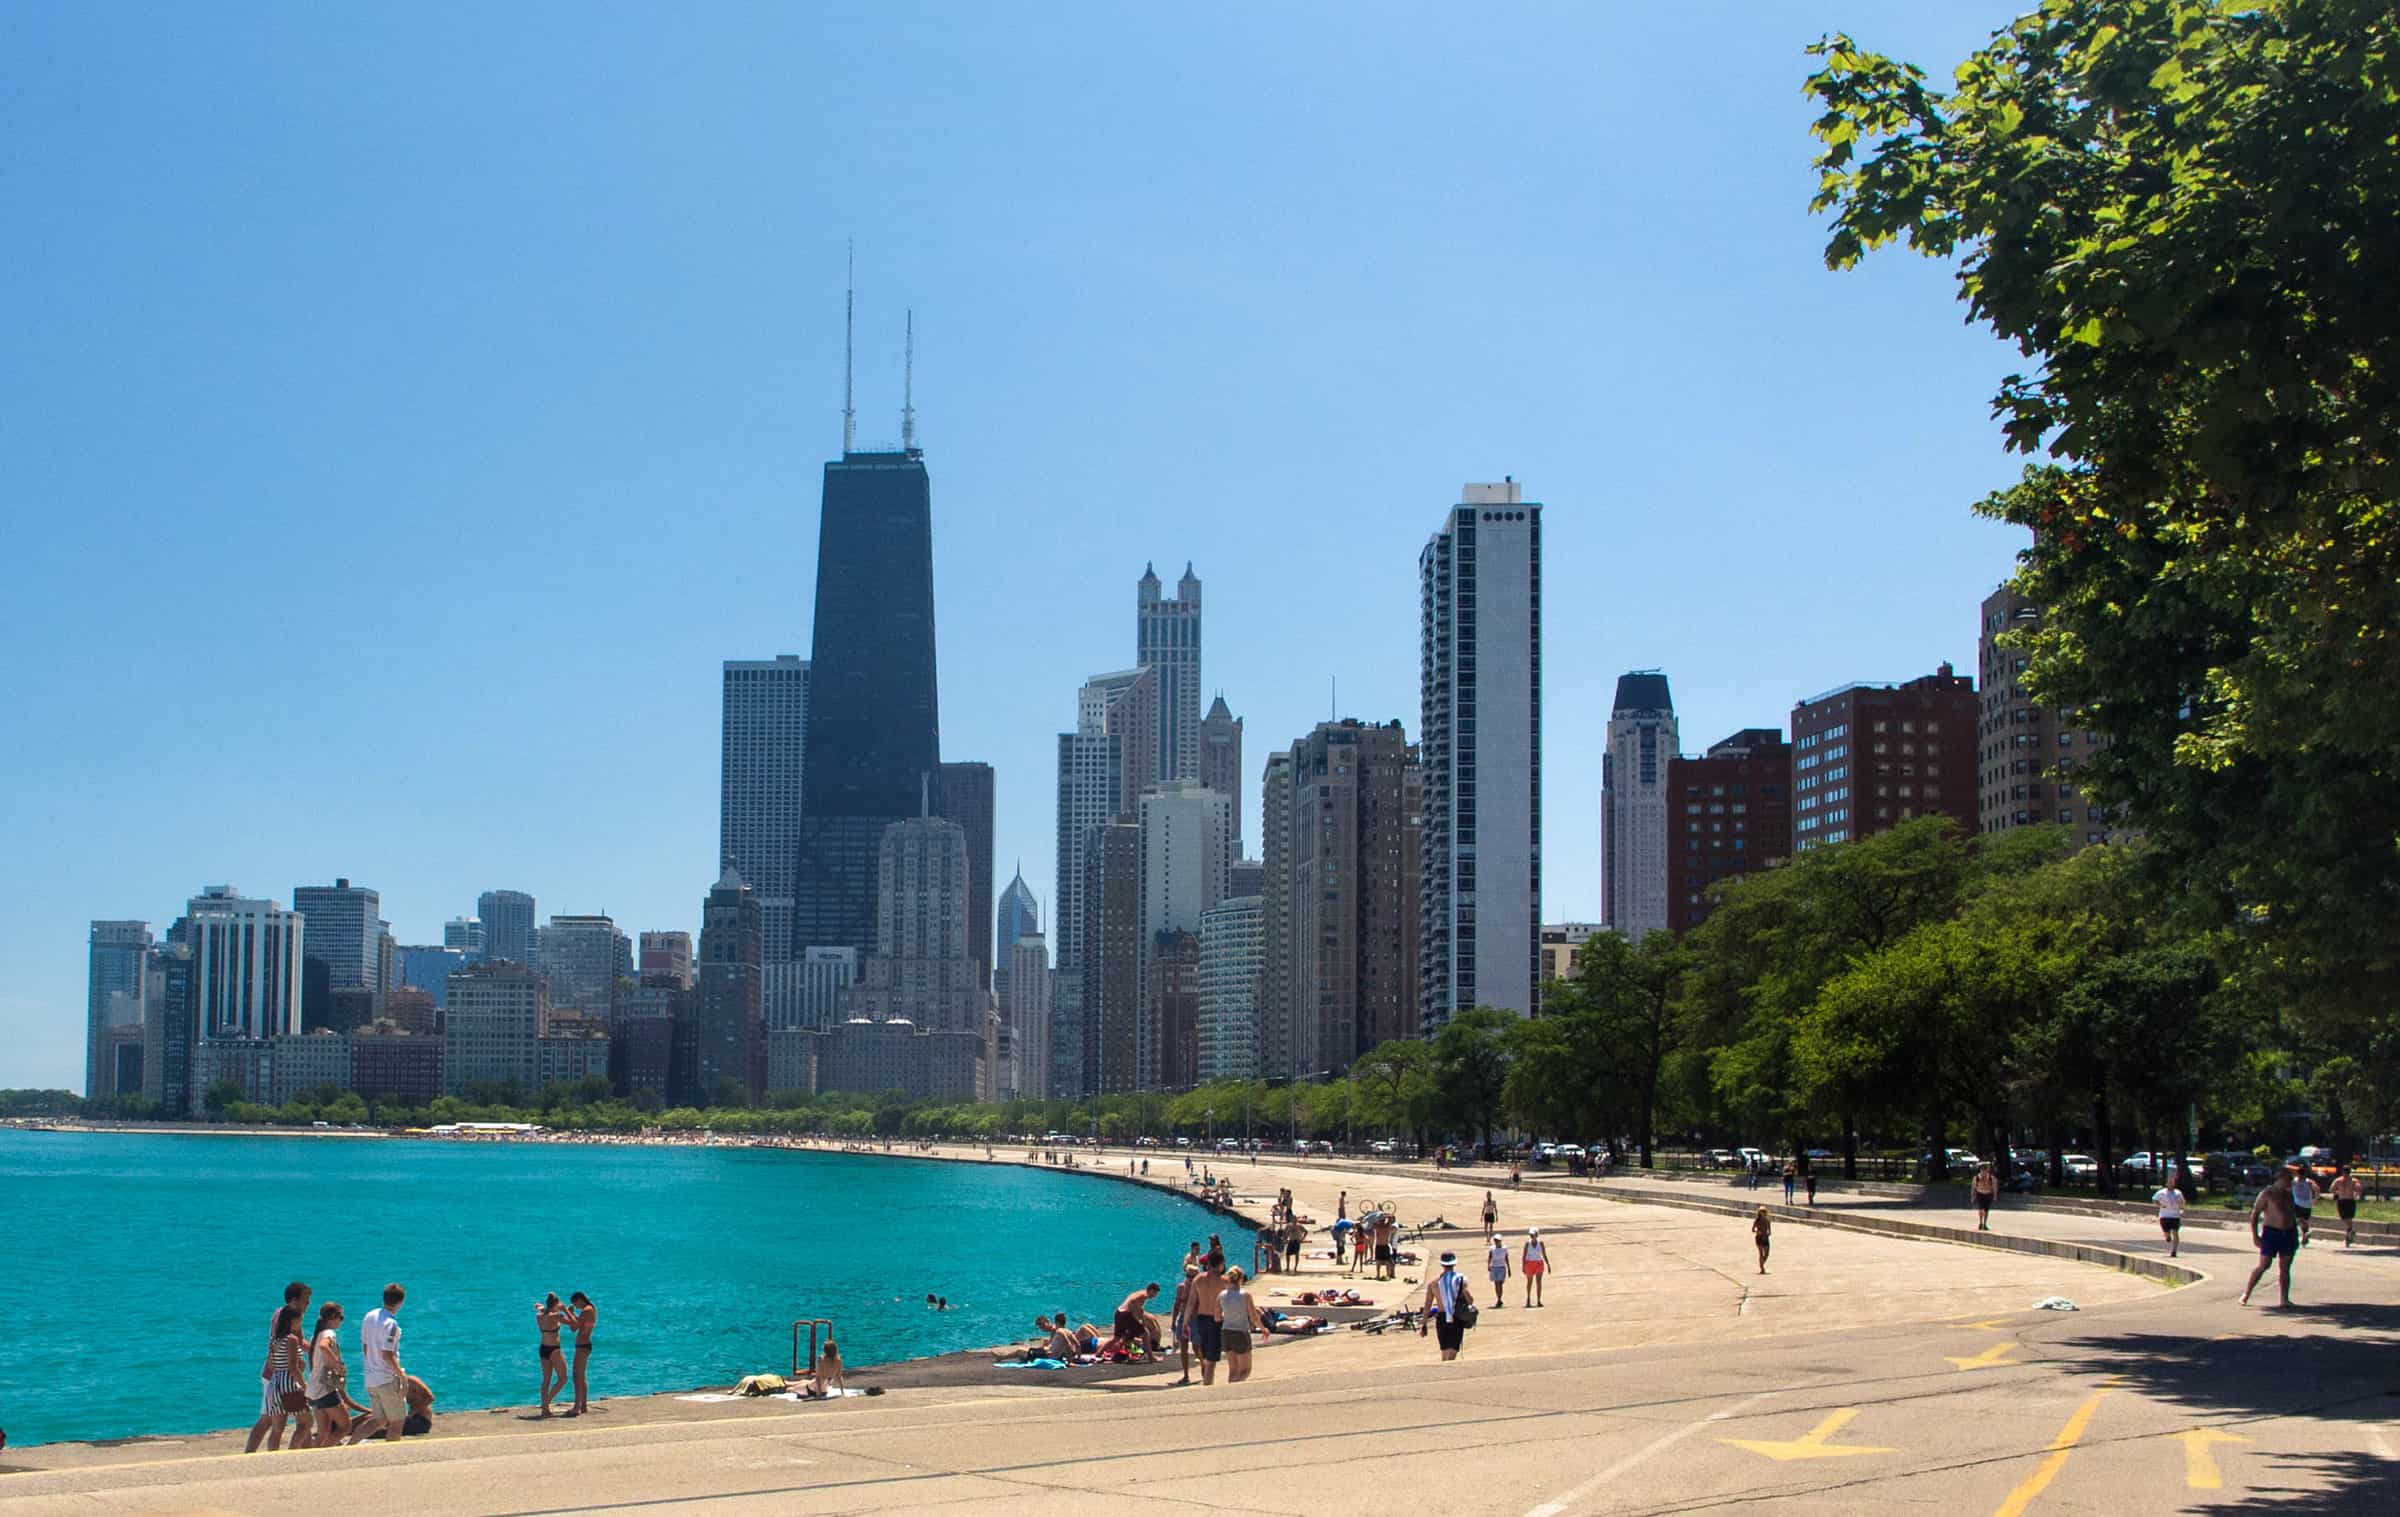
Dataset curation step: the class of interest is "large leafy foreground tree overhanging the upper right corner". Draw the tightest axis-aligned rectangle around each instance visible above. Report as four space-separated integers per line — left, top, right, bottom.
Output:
1810 0 2400 1035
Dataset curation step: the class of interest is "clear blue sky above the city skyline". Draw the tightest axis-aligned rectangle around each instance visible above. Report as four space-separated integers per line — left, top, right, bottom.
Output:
0 0 2021 1087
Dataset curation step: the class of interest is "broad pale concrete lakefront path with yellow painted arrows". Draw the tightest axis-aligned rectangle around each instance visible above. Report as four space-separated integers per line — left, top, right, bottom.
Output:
0 1150 2400 1517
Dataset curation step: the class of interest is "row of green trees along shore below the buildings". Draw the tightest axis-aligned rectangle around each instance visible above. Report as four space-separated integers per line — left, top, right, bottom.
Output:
0 819 2400 1181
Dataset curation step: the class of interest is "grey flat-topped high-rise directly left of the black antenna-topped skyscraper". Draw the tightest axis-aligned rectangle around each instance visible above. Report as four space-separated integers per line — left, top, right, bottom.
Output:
718 653 809 965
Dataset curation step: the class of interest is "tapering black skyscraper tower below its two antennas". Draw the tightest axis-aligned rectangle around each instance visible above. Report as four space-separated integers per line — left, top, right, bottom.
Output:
792 449 941 958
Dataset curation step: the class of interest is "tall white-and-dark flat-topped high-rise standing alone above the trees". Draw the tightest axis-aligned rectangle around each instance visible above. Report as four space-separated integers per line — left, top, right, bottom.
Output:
1416 480 1541 1035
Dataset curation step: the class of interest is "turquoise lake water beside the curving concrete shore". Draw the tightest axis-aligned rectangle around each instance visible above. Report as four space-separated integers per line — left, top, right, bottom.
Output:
0 1131 1250 1445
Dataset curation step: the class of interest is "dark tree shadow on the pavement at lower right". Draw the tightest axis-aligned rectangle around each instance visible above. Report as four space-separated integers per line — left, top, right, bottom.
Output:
2059 1282 2400 1515
